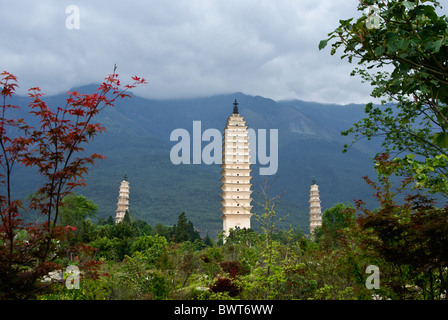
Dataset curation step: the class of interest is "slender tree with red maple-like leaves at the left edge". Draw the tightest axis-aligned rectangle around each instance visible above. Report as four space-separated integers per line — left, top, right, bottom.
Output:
0 68 145 298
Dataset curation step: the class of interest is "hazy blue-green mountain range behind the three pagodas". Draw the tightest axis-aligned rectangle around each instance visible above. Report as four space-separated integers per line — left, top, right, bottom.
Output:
6 86 378 236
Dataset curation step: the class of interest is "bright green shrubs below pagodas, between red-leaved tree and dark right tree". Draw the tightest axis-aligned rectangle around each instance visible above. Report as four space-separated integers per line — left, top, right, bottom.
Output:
40 188 392 299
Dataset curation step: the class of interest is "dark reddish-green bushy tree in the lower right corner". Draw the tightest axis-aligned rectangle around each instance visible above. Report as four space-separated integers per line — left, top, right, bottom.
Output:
356 154 448 300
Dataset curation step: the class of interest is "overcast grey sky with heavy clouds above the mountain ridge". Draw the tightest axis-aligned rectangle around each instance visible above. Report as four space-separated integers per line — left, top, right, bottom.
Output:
0 0 412 104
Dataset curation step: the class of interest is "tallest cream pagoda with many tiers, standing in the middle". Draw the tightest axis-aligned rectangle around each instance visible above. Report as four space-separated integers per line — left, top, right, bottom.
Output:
221 99 252 236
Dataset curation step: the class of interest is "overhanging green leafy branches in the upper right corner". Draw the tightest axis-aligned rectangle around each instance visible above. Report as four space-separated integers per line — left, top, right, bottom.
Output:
319 0 448 195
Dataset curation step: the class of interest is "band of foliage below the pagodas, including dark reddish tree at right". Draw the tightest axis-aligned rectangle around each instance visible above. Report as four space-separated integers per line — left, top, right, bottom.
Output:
36 188 448 300
